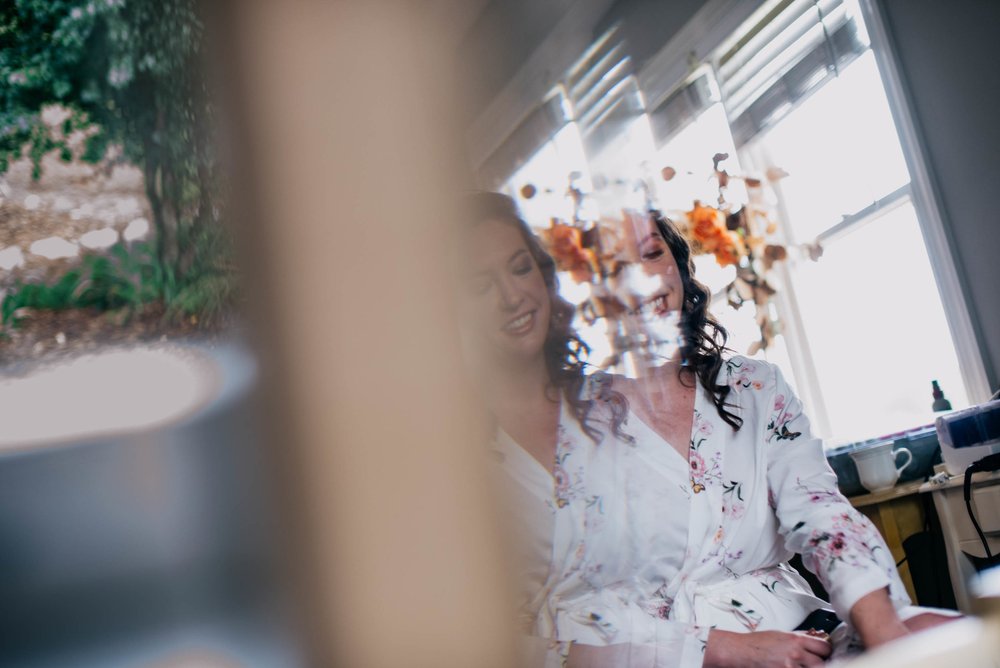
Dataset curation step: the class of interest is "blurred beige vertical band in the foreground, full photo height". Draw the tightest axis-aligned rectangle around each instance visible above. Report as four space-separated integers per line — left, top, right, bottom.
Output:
224 0 512 667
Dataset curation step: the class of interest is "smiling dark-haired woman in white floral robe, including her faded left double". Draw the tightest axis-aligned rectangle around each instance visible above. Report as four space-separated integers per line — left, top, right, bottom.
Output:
459 194 944 667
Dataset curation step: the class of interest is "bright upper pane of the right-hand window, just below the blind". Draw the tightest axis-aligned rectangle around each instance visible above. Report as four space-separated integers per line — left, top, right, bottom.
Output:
763 51 910 241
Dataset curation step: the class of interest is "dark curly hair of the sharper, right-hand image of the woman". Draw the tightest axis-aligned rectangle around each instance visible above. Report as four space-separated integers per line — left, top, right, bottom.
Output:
649 209 743 431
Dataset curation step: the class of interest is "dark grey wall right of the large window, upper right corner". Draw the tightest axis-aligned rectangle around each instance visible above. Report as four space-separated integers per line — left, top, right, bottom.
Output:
879 0 1000 389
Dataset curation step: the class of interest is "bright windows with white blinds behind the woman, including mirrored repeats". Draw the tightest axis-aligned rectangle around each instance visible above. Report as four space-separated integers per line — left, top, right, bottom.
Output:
492 0 984 447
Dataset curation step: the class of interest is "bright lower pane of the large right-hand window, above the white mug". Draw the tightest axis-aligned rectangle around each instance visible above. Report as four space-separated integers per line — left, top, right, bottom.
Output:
794 203 968 441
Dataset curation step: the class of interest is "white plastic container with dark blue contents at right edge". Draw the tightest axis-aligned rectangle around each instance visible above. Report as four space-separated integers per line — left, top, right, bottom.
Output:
936 401 1000 475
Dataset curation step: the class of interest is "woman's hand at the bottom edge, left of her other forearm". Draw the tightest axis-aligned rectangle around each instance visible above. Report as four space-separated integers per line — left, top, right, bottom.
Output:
705 629 833 668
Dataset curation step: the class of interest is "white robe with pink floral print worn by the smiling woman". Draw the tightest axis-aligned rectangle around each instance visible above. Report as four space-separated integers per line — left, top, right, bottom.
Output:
496 357 909 666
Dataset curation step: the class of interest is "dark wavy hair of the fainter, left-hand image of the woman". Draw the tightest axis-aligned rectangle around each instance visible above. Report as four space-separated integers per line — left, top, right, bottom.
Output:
468 192 632 441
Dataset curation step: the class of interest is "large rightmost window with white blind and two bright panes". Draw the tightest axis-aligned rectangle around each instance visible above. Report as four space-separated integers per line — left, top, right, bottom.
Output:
730 3 968 445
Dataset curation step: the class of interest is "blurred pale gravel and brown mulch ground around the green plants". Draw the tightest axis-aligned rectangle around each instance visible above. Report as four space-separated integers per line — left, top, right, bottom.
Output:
0 143 231 376
